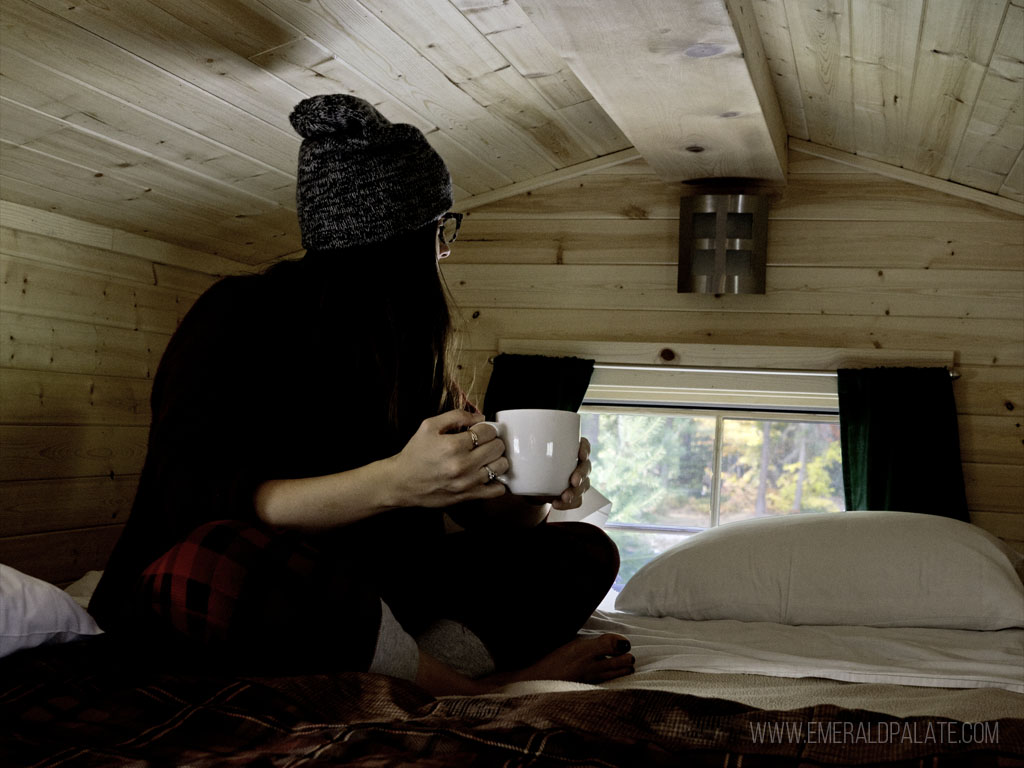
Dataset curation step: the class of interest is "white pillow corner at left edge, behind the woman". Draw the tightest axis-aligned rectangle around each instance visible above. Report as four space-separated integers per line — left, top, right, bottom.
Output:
0 565 102 657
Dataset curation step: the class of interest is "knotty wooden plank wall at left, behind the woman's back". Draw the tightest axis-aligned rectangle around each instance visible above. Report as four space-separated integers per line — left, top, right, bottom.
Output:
0 203 240 584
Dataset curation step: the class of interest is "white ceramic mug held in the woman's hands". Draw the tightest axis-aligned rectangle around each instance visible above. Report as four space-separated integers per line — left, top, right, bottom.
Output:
487 409 580 496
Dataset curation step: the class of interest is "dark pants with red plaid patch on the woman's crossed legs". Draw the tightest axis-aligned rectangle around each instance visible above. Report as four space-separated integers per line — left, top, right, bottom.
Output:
136 520 618 673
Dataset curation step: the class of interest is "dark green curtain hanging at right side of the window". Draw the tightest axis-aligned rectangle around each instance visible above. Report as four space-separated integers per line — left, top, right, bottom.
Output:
839 368 970 522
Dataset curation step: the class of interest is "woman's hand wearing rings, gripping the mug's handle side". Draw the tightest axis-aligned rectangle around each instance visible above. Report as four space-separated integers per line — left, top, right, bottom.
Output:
387 411 509 507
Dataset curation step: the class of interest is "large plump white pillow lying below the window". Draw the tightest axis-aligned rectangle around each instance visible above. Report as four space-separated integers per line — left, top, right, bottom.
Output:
615 512 1024 630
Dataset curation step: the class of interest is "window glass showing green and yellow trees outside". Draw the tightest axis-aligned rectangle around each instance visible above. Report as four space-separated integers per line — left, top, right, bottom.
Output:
581 406 844 590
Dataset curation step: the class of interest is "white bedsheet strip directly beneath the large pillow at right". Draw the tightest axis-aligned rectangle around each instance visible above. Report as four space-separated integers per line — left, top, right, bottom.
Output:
584 610 1024 693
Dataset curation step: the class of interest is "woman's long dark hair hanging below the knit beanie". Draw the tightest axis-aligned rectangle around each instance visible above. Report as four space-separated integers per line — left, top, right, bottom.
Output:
290 222 465 443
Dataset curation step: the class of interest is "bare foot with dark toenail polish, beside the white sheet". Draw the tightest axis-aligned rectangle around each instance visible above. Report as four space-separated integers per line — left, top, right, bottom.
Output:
480 634 636 686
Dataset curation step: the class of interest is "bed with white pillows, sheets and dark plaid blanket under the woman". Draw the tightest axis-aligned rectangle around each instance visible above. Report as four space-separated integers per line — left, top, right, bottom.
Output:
0 512 1024 768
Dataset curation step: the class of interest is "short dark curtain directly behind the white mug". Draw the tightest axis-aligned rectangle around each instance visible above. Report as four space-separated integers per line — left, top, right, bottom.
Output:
483 354 594 421
